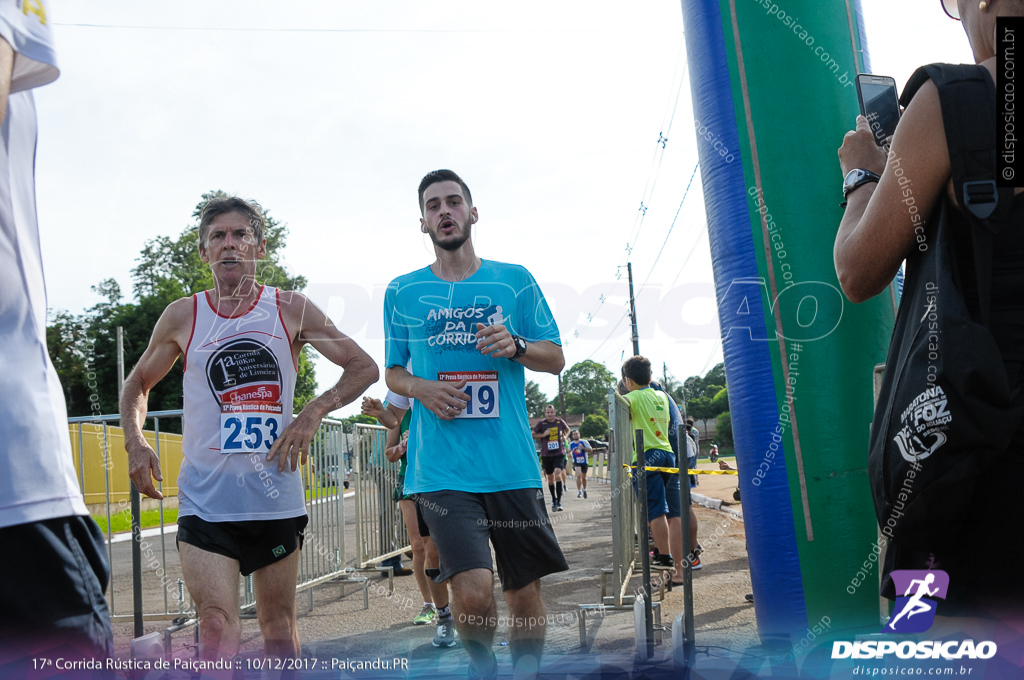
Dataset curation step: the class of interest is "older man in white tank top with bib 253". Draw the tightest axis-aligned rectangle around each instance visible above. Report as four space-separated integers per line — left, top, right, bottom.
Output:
121 198 379 658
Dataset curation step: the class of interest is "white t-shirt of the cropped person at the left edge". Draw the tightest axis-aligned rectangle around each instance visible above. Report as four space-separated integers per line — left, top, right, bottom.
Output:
0 6 80 526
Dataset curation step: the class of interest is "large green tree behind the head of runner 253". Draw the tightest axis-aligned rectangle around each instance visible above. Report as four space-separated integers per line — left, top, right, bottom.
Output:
47 192 316 428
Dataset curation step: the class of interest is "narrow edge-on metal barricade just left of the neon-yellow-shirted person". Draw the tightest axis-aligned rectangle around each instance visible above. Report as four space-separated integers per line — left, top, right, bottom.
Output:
608 390 637 606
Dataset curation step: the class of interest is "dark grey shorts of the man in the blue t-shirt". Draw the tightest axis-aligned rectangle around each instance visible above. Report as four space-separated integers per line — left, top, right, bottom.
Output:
417 488 569 591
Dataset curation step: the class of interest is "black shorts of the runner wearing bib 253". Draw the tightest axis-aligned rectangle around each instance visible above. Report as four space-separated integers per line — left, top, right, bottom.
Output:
177 515 309 577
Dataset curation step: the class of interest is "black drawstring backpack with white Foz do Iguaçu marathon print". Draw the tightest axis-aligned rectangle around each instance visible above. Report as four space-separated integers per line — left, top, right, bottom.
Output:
868 65 1024 551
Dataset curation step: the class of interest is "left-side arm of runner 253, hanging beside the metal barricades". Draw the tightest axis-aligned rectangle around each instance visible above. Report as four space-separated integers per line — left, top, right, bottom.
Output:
120 298 193 499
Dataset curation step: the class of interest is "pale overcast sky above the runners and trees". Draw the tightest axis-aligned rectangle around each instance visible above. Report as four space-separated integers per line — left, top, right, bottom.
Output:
36 0 971 416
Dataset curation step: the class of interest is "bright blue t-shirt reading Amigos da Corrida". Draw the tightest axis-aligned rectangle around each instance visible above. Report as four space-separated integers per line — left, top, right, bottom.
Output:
384 260 561 494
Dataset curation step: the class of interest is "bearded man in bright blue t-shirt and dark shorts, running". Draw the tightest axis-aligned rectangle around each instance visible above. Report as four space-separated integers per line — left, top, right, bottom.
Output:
384 170 568 677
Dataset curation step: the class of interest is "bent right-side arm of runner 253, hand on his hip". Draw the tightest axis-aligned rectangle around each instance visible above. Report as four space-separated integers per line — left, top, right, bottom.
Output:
266 293 380 471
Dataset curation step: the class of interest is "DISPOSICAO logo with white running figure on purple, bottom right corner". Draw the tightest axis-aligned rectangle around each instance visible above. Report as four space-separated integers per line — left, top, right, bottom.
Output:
831 569 996 660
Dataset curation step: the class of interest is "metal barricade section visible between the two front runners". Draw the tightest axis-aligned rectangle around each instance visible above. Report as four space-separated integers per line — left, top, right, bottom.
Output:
351 424 410 569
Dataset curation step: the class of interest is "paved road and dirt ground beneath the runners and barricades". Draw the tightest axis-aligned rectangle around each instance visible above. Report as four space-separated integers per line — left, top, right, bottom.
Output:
108 466 767 677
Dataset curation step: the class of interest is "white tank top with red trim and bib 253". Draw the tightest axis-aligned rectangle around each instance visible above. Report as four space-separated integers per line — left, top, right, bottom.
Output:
178 286 306 521
